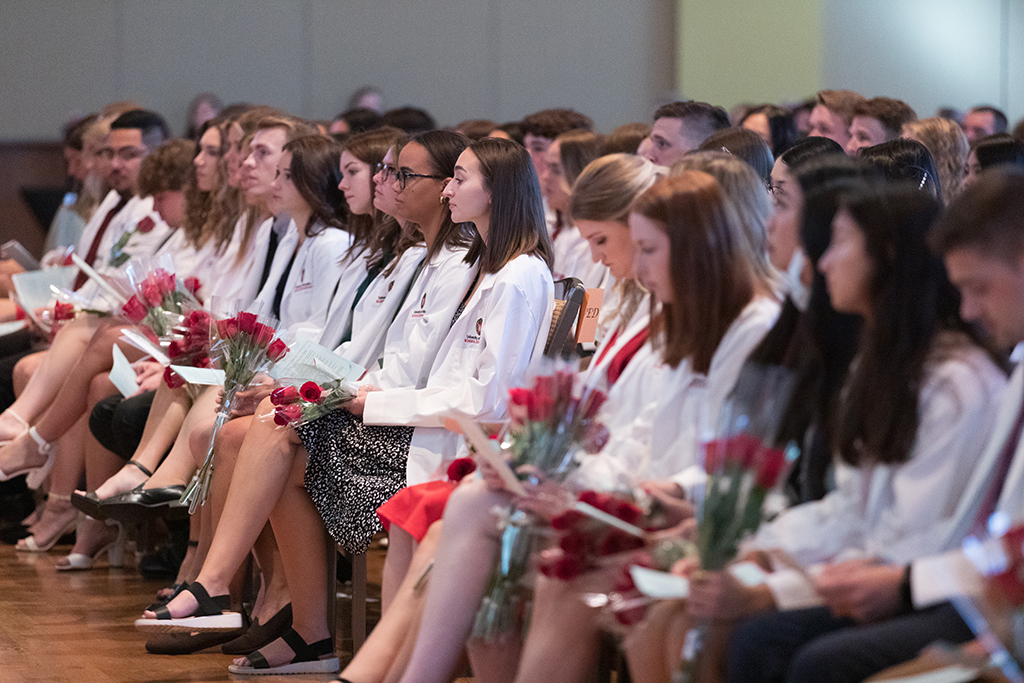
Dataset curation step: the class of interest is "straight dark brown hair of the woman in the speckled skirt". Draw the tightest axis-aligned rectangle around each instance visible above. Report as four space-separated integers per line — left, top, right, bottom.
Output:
466 137 553 272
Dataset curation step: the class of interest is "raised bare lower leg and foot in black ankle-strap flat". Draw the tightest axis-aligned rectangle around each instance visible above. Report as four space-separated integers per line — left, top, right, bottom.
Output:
96 382 191 500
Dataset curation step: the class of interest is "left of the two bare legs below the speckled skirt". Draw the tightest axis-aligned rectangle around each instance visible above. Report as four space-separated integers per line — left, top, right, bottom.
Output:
144 399 299 618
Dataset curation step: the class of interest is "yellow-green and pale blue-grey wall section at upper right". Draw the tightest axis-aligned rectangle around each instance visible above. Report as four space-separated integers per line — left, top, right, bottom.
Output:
678 0 1024 120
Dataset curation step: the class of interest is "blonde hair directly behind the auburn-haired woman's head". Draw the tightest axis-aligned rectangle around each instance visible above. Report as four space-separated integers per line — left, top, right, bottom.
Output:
670 152 781 292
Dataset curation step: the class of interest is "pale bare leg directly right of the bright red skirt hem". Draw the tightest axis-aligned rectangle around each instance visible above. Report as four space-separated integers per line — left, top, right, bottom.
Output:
401 480 516 683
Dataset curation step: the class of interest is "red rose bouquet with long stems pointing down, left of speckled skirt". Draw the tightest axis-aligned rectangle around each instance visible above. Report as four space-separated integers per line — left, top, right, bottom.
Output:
181 310 288 513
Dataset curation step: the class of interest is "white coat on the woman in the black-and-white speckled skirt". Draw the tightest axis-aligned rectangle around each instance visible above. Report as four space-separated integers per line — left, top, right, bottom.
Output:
362 255 554 485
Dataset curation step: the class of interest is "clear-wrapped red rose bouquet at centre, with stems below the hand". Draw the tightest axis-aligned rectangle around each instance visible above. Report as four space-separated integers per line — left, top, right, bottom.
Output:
472 360 607 642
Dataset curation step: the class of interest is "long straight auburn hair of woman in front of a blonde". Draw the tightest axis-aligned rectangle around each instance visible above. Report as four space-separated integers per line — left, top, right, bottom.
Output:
633 171 757 373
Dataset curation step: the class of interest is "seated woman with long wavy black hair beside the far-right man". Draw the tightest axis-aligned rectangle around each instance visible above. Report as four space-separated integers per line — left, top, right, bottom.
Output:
688 184 1006 681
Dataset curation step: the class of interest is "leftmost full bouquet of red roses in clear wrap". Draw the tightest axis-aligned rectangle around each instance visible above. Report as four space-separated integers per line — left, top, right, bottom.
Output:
121 254 202 343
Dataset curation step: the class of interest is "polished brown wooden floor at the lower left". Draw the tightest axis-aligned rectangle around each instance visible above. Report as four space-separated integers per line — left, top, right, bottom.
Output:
0 545 383 683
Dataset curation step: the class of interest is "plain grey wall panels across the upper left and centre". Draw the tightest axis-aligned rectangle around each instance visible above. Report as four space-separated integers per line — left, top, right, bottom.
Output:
0 0 676 140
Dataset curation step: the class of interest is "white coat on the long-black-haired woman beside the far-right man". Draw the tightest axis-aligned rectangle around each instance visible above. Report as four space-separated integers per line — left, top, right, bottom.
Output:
746 339 1006 609
